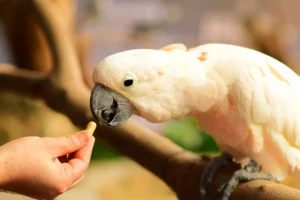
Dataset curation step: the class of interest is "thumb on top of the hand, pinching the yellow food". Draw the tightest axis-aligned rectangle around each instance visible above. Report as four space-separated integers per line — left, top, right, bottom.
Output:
50 130 92 157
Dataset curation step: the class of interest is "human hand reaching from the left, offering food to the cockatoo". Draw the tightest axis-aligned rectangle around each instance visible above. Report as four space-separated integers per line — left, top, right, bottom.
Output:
0 122 96 199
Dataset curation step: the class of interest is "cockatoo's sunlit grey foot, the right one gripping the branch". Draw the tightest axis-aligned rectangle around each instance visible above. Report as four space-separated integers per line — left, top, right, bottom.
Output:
219 160 278 200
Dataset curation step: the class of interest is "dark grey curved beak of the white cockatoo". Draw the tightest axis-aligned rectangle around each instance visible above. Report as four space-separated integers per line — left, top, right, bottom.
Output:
90 83 134 126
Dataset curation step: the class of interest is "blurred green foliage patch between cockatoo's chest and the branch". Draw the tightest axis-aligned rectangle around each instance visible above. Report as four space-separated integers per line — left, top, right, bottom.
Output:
163 117 219 153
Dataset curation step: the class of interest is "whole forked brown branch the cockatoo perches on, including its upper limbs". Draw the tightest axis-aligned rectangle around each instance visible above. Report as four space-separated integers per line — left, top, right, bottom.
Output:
0 0 300 200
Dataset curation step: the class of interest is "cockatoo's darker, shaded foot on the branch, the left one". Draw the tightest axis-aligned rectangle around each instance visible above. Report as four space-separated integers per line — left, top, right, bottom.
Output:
200 152 233 200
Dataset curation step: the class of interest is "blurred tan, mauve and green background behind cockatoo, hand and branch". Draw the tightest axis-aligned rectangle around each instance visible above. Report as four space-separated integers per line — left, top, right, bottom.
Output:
0 0 300 200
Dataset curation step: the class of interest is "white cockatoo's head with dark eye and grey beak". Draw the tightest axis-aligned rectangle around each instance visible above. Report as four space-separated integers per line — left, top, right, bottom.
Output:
90 44 206 126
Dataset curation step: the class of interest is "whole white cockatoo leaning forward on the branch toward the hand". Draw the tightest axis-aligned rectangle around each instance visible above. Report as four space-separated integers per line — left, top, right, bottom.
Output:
91 44 300 199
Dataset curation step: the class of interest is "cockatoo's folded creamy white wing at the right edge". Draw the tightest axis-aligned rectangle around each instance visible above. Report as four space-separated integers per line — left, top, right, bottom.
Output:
232 50 300 178
